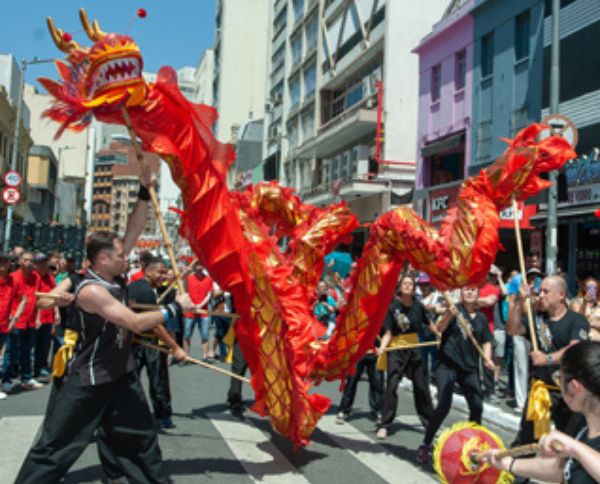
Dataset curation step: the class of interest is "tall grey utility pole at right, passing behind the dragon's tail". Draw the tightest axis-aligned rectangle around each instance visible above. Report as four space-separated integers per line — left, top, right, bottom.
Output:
546 0 560 274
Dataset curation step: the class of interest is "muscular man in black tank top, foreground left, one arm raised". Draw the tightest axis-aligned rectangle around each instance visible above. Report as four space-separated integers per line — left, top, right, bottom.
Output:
16 178 195 483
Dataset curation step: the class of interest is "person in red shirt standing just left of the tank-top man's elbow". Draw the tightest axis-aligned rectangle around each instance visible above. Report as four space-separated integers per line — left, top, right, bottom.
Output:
33 252 57 378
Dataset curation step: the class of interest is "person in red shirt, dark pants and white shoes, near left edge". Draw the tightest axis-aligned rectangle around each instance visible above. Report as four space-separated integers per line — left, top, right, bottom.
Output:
2 252 43 393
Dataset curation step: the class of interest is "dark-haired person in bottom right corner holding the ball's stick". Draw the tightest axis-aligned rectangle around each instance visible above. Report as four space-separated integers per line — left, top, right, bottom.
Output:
481 341 600 484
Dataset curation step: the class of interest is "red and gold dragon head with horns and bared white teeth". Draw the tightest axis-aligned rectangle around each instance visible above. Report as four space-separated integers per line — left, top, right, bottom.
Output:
39 9 147 137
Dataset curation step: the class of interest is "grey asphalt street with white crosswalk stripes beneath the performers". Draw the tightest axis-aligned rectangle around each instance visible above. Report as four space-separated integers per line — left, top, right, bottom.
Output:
0 345 514 484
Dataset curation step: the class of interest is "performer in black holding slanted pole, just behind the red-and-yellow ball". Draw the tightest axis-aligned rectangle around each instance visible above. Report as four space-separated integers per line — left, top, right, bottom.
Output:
417 287 494 464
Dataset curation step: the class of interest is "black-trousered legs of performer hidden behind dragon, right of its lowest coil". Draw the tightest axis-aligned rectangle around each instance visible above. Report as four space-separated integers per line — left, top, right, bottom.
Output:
337 342 383 423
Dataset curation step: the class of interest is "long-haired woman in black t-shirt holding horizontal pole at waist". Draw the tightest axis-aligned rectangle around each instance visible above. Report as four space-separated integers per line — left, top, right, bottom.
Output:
377 276 433 439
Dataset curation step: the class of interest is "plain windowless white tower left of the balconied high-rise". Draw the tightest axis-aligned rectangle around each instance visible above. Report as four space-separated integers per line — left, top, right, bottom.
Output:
213 0 271 142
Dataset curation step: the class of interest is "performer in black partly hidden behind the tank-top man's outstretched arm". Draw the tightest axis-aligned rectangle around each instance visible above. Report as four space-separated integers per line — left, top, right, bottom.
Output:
127 256 185 429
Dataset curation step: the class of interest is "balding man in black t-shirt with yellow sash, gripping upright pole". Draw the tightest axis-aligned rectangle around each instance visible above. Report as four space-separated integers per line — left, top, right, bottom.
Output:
506 276 590 445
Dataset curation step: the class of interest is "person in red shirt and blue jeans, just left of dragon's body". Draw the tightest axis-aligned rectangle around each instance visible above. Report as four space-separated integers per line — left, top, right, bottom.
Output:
183 264 215 361
